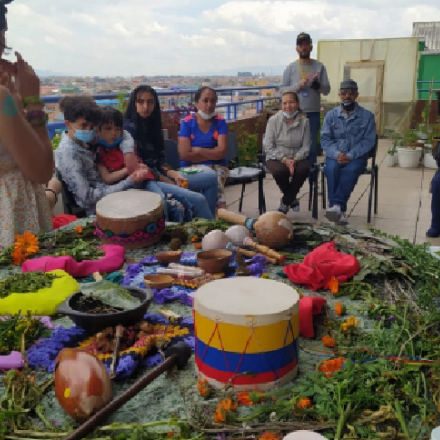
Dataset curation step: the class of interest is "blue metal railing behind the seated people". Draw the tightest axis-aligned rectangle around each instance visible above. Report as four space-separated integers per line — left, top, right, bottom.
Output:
41 85 277 139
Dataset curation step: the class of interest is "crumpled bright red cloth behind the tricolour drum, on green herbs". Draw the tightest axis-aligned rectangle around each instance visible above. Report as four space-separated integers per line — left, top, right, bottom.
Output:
284 241 360 290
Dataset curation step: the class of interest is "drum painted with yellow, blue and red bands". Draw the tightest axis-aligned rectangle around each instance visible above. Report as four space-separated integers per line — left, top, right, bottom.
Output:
193 277 299 391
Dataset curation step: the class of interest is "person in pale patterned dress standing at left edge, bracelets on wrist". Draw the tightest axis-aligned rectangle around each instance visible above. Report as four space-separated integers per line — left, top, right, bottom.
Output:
0 0 53 248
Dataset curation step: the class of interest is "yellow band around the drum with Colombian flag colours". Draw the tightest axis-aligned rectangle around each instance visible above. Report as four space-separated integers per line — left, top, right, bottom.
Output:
194 311 299 353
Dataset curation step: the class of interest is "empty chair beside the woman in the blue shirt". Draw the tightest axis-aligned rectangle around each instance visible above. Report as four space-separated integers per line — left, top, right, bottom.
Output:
226 133 266 215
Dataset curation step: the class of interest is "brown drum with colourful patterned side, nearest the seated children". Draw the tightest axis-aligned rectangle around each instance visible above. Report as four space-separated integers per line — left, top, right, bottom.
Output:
95 189 165 249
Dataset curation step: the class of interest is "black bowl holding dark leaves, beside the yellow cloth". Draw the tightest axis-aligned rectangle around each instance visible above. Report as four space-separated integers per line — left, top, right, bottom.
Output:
57 287 153 334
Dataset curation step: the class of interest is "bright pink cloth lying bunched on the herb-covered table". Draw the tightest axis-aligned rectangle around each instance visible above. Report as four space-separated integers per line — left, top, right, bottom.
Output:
21 244 125 278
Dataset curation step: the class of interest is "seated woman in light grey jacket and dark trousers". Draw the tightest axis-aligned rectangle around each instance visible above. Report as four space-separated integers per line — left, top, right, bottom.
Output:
264 90 310 214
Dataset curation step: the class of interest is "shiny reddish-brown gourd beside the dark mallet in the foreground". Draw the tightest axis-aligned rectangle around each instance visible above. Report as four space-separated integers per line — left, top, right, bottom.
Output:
55 348 112 421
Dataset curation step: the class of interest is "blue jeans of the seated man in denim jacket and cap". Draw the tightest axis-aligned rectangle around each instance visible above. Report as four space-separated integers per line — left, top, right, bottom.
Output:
324 155 368 212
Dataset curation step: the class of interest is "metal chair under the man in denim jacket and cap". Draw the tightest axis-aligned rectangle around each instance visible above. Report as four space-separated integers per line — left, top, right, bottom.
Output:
309 135 379 223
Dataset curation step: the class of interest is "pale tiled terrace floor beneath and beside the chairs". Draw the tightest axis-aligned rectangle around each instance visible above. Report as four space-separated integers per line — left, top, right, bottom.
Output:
226 139 440 245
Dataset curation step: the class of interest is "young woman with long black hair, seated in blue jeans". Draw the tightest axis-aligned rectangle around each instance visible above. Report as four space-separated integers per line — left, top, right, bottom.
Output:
123 86 217 220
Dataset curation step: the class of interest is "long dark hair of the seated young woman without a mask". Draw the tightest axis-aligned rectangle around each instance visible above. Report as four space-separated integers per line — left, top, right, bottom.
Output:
124 85 164 152
